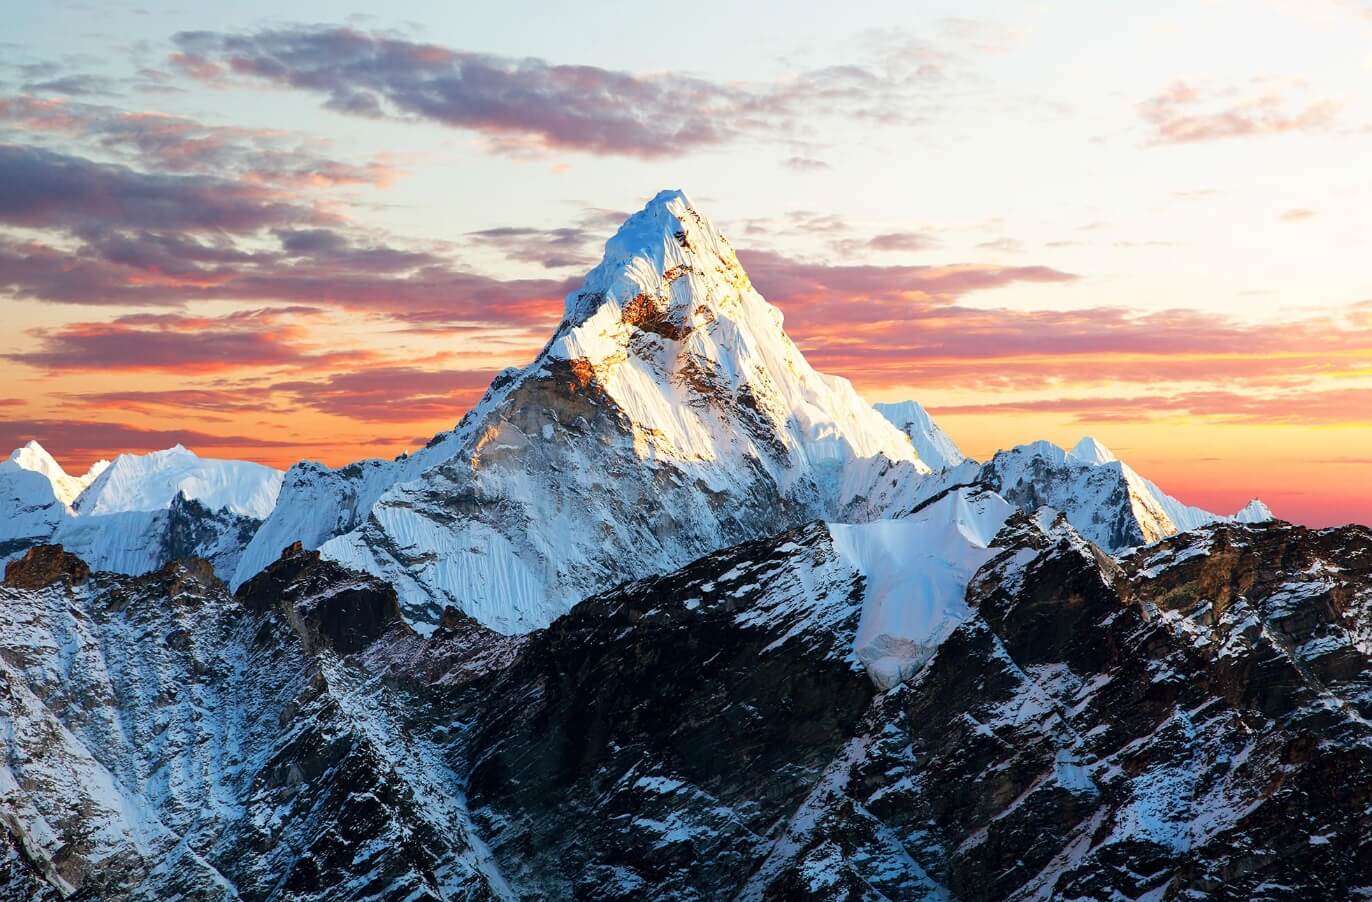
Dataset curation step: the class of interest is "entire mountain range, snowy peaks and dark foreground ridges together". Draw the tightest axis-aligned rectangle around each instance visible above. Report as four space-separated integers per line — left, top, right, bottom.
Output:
0 191 1372 899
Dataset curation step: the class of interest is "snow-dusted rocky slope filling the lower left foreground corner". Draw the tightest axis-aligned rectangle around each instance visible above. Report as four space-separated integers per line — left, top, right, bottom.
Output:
0 556 510 899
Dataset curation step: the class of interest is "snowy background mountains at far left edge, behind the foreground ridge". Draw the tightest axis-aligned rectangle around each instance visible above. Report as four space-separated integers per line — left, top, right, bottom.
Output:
0 442 281 579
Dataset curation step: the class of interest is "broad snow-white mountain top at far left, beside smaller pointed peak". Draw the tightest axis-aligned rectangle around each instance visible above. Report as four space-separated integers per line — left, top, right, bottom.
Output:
73 445 283 520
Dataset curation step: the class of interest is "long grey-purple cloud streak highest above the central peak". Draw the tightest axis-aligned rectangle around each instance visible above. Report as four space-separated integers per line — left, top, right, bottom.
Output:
172 26 960 158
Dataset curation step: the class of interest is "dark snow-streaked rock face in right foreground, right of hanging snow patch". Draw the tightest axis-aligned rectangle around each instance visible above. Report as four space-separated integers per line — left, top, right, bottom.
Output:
744 522 1372 899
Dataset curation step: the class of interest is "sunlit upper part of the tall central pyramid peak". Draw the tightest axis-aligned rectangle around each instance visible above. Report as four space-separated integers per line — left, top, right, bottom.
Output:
543 191 918 467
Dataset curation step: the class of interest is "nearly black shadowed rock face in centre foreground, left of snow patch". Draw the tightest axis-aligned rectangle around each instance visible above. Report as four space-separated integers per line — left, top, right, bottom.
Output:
468 524 874 899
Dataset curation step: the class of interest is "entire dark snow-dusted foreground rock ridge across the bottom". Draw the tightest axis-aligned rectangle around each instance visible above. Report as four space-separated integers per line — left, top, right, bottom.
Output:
0 513 1372 899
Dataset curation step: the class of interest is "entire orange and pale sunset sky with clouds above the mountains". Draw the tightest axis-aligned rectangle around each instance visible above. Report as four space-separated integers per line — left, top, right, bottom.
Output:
0 0 1372 526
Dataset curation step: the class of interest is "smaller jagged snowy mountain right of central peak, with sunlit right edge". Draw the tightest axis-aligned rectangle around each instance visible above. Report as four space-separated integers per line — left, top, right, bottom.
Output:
973 438 1272 552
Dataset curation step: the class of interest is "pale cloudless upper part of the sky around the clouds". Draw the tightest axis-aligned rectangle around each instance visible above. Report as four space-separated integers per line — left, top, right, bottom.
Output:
8 0 1372 316
